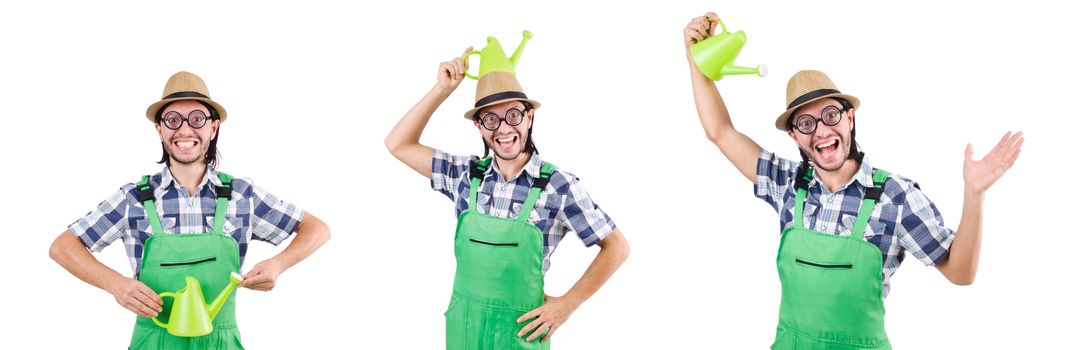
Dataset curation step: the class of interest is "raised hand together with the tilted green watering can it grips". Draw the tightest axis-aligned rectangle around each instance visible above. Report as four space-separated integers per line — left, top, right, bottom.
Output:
684 12 768 80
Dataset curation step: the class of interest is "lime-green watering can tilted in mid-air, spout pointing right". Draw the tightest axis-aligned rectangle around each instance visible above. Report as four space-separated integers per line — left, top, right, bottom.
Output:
691 19 769 80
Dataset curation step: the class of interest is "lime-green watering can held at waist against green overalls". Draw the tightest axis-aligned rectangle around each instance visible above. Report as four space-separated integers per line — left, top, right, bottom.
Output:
151 272 244 336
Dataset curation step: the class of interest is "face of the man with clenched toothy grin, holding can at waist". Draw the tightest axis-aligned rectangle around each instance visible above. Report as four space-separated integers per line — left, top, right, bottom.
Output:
155 100 219 165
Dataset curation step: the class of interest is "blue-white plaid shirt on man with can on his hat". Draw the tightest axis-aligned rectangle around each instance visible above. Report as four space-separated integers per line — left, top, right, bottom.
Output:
431 150 616 272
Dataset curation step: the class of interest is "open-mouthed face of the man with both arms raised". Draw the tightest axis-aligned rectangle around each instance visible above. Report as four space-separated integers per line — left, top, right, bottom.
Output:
788 98 854 171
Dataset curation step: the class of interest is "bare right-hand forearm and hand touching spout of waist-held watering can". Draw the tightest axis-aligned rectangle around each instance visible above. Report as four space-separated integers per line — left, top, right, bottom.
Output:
241 212 330 291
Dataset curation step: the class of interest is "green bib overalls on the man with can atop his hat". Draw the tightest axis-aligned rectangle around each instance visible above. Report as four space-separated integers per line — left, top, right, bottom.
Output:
444 157 555 350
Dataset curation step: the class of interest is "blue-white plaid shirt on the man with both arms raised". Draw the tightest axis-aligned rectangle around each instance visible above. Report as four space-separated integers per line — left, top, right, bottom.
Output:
754 150 954 298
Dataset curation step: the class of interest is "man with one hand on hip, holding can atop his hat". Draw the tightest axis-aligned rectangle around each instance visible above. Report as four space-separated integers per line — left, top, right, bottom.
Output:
384 49 628 349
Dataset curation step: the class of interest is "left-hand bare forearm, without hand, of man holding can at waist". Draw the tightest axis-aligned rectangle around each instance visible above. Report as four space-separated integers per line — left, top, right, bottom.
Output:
48 230 126 293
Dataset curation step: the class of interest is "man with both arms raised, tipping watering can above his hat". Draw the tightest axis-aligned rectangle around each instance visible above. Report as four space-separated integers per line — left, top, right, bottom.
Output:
684 13 1023 349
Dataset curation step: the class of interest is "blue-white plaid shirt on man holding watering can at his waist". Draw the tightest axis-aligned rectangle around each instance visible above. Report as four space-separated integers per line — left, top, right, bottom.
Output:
69 167 304 276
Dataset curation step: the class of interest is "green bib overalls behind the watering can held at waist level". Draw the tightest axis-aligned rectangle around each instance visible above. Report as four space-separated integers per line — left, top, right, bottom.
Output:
130 172 244 350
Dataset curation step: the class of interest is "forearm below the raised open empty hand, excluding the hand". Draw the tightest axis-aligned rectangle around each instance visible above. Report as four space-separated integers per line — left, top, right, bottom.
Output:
940 190 984 285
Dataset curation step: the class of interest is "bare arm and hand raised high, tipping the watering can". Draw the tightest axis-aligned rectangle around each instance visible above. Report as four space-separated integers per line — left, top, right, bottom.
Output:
684 12 761 182
